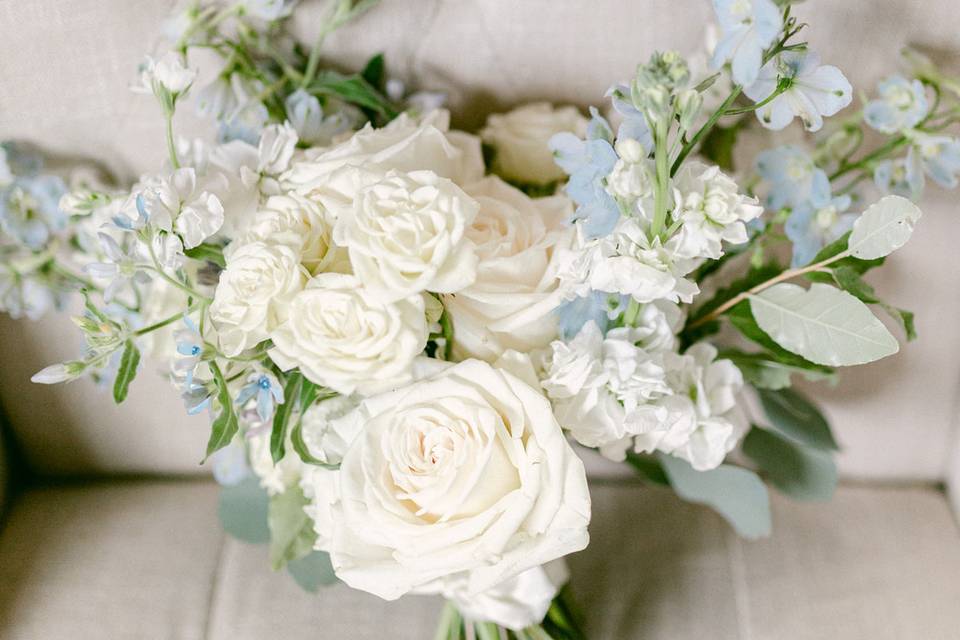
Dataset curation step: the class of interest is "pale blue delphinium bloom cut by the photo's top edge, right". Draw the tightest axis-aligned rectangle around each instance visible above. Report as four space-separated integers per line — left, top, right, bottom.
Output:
713 0 783 87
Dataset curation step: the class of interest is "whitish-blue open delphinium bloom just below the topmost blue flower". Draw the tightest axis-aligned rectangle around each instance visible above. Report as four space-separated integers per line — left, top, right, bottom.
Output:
743 51 853 131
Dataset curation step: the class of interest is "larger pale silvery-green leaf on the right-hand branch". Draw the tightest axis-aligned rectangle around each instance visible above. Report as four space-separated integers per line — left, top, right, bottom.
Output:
750 283 900 366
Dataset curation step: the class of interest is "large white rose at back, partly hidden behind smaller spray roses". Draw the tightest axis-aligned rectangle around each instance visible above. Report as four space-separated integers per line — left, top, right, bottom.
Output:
281 111 484 204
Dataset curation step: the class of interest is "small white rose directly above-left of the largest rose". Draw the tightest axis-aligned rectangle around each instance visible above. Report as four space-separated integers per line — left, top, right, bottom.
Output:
269 273 428 395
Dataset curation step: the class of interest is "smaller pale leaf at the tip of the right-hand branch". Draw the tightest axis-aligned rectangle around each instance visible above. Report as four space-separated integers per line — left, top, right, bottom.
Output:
847 196 920 260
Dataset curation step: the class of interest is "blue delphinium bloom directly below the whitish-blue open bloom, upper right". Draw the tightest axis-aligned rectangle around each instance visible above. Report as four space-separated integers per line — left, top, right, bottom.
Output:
757 145 830 211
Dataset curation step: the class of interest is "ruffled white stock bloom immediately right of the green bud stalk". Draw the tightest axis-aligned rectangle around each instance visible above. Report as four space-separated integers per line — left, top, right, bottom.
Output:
673 160 763 260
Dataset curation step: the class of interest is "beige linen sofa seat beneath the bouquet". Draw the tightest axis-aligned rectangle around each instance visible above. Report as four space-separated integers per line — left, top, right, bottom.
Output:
0 481 960 640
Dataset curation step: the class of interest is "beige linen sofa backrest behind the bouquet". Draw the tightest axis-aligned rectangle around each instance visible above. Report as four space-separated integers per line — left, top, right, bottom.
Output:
0 0 960 498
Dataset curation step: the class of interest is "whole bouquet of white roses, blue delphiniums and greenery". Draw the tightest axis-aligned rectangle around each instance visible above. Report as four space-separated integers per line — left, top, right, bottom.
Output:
0 0 960 640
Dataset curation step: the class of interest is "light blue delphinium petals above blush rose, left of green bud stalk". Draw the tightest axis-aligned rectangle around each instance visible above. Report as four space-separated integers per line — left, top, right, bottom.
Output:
550 113 620 238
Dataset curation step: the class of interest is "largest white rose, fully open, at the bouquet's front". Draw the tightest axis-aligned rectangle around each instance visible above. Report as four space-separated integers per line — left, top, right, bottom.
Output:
330 355 590 600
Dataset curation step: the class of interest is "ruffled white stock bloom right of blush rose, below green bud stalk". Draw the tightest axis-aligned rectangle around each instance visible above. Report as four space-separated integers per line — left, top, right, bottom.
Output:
585 217 700 302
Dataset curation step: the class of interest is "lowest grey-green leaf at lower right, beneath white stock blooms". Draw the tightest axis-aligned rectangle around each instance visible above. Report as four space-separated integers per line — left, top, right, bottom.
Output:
658 454 771 539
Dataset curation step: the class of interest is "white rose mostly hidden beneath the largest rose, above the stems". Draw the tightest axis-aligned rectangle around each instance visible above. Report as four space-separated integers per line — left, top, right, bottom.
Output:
420 559 570 630
